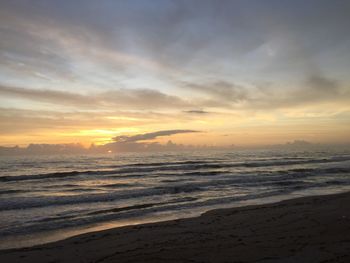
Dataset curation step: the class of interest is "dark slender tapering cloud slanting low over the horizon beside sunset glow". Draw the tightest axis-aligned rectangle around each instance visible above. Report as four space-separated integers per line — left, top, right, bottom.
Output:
113 130 199 143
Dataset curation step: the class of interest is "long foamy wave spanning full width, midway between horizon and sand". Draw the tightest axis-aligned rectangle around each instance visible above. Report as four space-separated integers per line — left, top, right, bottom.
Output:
0 168 350 210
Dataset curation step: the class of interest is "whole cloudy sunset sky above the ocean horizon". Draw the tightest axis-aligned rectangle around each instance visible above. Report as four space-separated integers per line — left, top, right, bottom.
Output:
0 0 350 146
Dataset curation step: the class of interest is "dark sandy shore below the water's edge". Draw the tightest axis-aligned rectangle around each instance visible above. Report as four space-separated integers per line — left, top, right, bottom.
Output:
0 193 350 263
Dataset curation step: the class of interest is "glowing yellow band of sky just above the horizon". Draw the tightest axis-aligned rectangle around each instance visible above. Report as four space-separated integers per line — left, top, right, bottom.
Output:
0 102 350 146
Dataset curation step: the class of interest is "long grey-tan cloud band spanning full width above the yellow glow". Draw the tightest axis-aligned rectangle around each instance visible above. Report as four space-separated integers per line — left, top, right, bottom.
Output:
0 74 350 115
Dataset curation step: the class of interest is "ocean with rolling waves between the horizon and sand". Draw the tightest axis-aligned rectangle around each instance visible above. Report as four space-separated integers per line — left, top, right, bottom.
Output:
0 150 350 249
